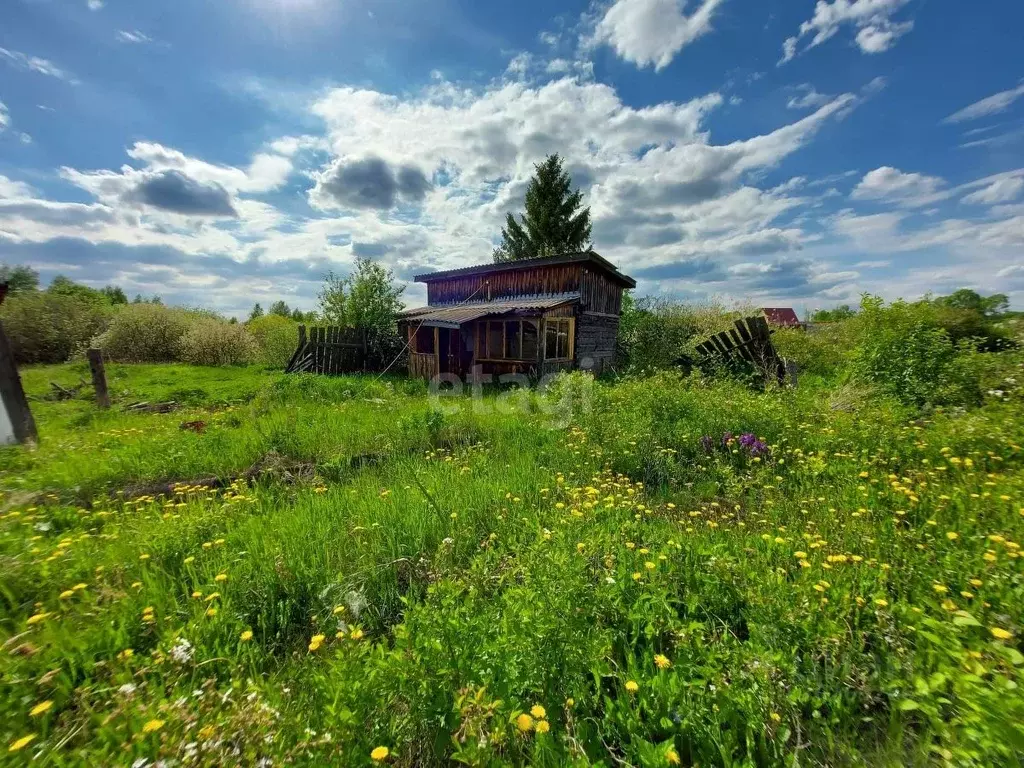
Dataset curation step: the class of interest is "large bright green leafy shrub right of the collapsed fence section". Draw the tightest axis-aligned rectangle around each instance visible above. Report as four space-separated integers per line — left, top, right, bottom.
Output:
851 296 981 406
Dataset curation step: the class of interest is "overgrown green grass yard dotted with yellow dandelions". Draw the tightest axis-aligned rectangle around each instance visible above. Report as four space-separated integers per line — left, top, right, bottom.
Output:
0 353 1024 766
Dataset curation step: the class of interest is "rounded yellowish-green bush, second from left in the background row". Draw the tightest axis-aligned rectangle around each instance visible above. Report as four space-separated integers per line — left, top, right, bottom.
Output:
93 304 189 362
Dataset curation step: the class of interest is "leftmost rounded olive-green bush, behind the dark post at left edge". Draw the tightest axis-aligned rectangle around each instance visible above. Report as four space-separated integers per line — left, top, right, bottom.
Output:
0 291 111 364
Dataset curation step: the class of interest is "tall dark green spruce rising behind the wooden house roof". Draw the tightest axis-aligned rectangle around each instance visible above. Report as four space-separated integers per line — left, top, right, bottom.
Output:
494 154 591 262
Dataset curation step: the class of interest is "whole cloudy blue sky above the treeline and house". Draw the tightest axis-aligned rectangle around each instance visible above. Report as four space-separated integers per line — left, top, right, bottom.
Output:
0 0 1024 316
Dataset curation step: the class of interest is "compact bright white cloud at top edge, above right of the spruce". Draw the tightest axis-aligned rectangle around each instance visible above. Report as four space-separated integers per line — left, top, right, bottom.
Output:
589 0 723 71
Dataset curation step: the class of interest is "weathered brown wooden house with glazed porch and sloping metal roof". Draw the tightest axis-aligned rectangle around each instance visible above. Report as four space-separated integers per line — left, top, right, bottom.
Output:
399 251 636 379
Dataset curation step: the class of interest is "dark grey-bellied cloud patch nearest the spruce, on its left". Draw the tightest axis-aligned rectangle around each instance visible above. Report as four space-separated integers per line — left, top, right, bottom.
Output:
309 157 430 210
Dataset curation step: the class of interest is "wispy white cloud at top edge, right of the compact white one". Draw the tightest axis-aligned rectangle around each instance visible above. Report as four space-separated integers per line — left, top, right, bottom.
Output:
779 0 913 65
